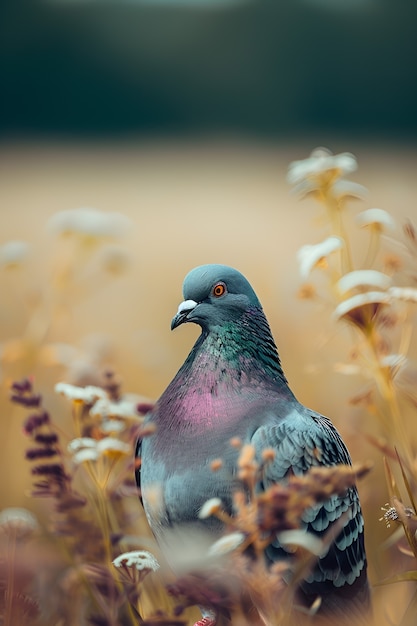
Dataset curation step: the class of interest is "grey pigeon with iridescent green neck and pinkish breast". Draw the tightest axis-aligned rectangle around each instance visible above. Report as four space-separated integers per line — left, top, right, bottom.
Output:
136 264 370 626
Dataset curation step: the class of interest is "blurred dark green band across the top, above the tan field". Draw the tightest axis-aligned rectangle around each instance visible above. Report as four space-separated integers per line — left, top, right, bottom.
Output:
0 0 417 140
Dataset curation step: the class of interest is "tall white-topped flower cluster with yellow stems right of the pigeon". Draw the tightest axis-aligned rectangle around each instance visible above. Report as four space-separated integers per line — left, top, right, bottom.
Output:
288 149 417 461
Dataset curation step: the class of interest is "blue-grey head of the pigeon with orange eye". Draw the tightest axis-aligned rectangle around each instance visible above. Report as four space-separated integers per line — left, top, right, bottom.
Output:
171 265 261 330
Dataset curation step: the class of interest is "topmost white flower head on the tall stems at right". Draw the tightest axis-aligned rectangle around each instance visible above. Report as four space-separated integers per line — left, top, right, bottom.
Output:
287 148 357 185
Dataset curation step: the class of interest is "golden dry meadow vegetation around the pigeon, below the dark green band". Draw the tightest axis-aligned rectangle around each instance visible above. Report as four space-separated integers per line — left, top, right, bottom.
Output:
0 141 417 626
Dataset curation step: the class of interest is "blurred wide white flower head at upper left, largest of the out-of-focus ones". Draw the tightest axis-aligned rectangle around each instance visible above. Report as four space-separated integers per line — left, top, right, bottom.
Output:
47 208 131 239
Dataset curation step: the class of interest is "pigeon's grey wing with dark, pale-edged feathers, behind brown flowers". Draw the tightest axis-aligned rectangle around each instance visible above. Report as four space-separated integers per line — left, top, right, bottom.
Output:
252 406 366 597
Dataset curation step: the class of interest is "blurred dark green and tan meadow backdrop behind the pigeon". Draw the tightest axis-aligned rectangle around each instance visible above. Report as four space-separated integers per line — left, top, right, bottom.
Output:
0 0 417 624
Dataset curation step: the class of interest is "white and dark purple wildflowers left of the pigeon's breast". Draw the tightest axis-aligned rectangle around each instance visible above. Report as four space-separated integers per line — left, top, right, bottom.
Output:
6 372 167 626
